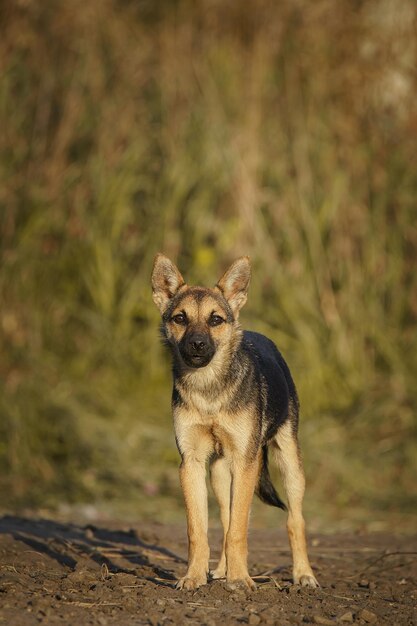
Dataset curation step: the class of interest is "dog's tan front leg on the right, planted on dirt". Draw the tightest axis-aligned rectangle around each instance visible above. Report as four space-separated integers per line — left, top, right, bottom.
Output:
226 459 259 589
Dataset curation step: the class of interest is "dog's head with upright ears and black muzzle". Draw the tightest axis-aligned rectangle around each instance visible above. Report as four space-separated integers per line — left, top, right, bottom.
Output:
152 254 250 368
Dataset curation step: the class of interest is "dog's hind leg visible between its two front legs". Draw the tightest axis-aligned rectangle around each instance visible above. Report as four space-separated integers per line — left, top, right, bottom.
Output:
210 457 232 578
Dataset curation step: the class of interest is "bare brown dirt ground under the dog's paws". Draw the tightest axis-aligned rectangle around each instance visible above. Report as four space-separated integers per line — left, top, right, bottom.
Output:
0 516 417 626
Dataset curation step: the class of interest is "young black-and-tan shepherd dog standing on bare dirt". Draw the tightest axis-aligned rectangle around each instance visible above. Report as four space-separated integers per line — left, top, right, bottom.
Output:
152 254 318 590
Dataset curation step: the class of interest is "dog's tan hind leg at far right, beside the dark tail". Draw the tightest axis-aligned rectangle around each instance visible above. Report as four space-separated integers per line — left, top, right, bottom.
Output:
274 420 319 587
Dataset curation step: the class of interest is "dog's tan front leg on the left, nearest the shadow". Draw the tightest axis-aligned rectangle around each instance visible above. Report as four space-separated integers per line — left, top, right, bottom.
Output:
177 454 209 589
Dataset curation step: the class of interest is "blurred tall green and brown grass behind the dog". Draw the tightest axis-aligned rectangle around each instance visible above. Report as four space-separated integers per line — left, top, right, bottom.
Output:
0 0 417 530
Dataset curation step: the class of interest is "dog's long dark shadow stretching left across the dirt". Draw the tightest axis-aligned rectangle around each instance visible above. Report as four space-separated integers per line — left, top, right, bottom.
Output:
0 515 186 586
